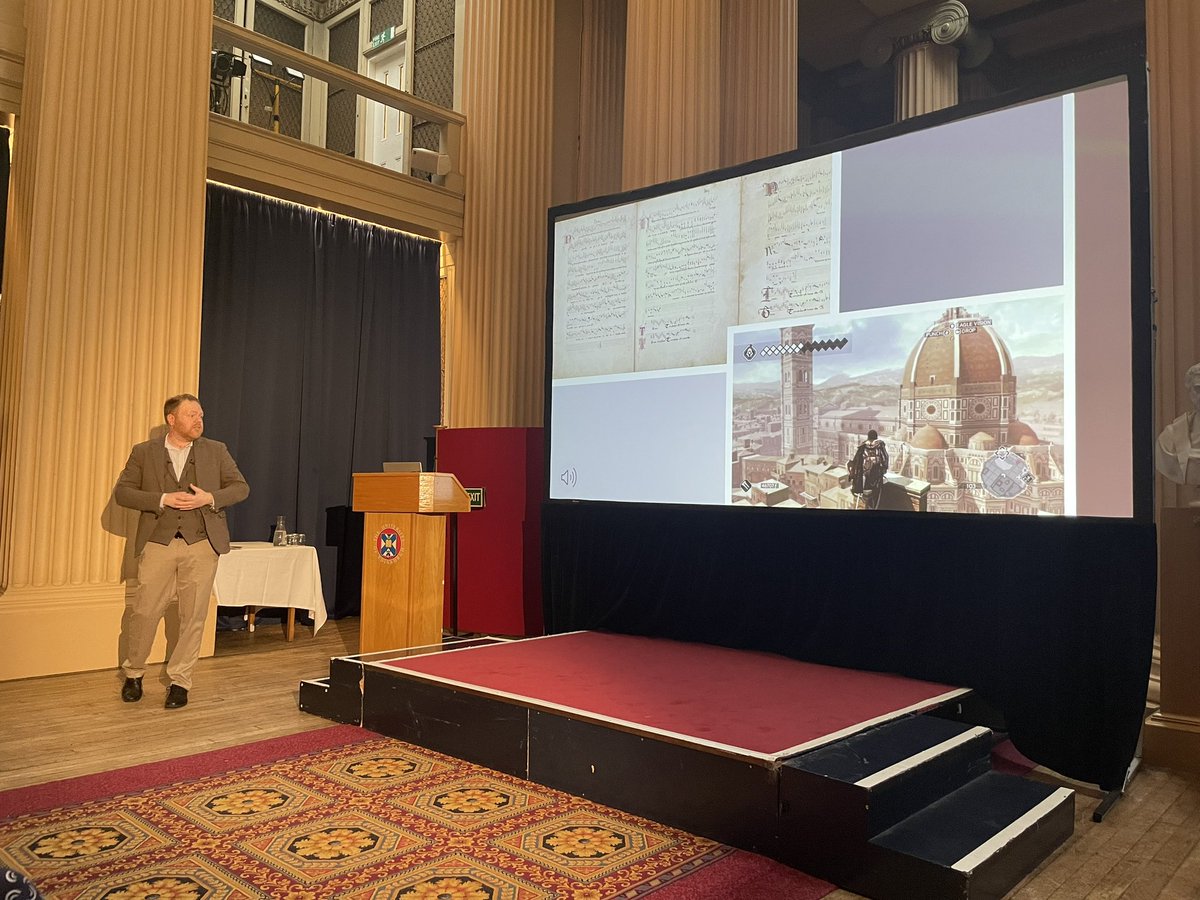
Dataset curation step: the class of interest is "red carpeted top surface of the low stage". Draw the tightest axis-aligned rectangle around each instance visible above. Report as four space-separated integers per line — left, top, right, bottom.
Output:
386 631 965 758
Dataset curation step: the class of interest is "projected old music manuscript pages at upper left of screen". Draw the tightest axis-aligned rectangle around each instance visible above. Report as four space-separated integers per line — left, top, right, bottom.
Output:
553 158 833 378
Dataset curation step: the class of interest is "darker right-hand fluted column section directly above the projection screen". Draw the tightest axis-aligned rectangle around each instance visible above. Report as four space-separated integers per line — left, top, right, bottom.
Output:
721 0 799 166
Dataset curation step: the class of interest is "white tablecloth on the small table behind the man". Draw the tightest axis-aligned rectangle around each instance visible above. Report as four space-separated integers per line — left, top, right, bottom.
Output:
212 541 326 635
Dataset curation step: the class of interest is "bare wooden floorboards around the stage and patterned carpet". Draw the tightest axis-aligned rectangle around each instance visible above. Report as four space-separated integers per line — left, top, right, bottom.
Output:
0 619 1200 900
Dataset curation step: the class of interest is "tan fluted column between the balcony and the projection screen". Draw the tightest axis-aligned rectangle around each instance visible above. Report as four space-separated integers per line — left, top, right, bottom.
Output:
443 0 554 427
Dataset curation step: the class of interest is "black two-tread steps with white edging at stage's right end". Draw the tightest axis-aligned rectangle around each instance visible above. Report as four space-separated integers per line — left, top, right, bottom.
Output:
780 715 1074 900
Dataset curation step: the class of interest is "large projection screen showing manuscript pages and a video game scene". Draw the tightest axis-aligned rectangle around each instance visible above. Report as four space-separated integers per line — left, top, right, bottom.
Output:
547 78 1140 516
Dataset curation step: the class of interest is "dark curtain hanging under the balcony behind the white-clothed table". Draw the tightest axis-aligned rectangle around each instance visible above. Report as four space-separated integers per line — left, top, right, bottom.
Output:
200 185 440 616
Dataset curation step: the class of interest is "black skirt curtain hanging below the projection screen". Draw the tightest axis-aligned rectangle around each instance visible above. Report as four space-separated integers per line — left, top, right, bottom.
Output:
542 503 1157 790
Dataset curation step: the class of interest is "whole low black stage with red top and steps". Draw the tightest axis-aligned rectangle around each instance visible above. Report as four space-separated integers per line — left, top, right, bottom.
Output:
300 631 1074 898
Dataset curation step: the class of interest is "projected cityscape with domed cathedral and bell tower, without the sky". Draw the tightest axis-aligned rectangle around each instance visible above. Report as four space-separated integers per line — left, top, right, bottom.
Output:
733 306 1066 515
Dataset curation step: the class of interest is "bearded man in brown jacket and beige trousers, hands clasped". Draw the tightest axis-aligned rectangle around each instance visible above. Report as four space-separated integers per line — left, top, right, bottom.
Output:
116 394 250 709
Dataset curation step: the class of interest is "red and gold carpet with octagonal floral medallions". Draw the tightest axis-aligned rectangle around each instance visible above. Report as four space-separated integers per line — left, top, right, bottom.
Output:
0 726 833 900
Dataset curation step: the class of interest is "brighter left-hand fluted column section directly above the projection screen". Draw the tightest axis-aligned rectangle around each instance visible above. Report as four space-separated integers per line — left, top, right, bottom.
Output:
622 0 721 190
